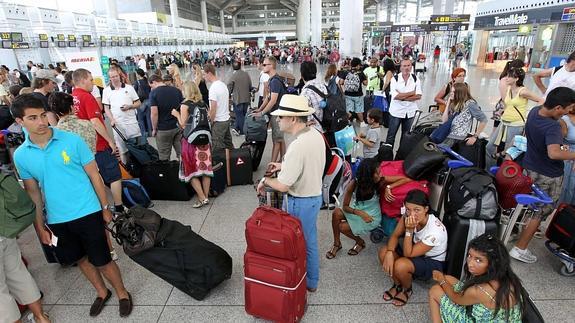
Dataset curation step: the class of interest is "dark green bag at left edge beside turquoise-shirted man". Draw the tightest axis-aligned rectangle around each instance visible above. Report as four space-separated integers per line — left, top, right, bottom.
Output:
0 173 36 238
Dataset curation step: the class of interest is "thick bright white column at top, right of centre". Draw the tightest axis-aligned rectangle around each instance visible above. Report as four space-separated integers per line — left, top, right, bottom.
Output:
339 0 364 58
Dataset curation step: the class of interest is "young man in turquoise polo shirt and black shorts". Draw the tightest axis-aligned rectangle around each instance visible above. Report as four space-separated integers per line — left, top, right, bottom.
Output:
10 94 133 317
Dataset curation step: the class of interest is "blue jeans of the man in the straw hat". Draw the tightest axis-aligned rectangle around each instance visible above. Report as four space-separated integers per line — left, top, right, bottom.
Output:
284 195 322 288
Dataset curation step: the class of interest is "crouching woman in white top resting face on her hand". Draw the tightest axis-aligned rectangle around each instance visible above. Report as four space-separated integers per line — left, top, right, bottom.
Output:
379 190 447 306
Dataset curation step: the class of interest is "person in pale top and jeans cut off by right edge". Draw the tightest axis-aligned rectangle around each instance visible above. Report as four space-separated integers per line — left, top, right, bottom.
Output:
559 110 575 205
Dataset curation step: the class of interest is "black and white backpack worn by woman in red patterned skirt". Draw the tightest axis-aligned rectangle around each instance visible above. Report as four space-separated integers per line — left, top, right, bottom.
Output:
183 101 212 146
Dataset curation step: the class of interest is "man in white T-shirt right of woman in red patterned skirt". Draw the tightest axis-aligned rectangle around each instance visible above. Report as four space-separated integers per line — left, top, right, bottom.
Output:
204 64 234 152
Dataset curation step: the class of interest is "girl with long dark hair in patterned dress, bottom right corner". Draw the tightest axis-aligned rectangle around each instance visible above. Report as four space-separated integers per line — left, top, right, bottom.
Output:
429 234 523 323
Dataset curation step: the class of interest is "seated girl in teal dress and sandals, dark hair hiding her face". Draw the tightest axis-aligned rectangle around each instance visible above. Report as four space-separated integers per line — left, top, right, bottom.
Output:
325 158 383 259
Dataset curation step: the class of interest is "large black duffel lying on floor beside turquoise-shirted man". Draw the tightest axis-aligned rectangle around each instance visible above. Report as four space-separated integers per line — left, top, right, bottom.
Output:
130 219 232 300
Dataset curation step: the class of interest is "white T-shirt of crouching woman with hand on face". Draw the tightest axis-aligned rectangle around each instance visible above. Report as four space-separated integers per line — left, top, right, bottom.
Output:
413 214 447 261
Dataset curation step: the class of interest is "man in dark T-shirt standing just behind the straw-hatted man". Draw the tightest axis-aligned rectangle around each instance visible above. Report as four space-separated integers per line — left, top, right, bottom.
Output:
253 56 287 162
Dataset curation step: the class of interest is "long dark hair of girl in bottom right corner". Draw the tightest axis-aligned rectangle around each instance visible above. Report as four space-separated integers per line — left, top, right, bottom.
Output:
462 233 523 321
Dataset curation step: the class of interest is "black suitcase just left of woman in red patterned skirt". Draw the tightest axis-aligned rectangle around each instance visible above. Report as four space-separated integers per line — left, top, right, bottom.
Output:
140 160 192 201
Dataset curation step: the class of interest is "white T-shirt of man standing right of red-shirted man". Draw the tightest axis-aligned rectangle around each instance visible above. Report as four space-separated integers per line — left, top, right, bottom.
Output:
102 84 139 125
